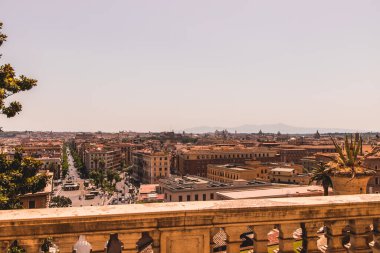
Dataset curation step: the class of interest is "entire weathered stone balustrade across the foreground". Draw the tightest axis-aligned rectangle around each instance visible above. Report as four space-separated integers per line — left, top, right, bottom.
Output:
0 195 380 253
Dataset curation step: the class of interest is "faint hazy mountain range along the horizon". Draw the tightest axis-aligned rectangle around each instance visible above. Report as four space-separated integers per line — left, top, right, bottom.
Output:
184 123 363 134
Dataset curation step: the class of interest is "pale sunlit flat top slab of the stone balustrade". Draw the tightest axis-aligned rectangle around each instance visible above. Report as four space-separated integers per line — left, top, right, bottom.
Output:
0 194 380 221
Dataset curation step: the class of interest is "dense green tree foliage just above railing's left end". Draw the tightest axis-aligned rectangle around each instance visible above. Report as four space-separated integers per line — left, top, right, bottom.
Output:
0 152 49 210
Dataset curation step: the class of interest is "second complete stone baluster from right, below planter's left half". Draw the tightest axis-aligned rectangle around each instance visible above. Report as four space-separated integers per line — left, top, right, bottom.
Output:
325 221 347 253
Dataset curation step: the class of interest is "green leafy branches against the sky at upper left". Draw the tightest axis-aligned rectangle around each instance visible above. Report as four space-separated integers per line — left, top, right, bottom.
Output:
0 22 37 125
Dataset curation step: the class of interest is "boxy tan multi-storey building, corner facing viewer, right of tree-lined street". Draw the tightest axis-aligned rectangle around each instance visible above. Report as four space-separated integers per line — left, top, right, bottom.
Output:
132 149 170 184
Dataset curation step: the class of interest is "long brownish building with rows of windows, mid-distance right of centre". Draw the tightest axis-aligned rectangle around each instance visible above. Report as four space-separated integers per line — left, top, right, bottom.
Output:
177 145 277 177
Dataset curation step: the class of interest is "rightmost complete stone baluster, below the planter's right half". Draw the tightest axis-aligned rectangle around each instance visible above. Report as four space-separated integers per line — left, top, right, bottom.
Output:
349 219 372 253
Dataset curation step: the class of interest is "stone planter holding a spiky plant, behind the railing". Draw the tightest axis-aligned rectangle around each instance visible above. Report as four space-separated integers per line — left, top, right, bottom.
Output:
331 174 373 195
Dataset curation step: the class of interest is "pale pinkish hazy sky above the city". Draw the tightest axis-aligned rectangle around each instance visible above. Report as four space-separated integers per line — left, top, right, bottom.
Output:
0 0 380 131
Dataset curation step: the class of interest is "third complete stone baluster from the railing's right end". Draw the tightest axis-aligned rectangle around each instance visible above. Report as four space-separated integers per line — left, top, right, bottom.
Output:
302 222 324 253
